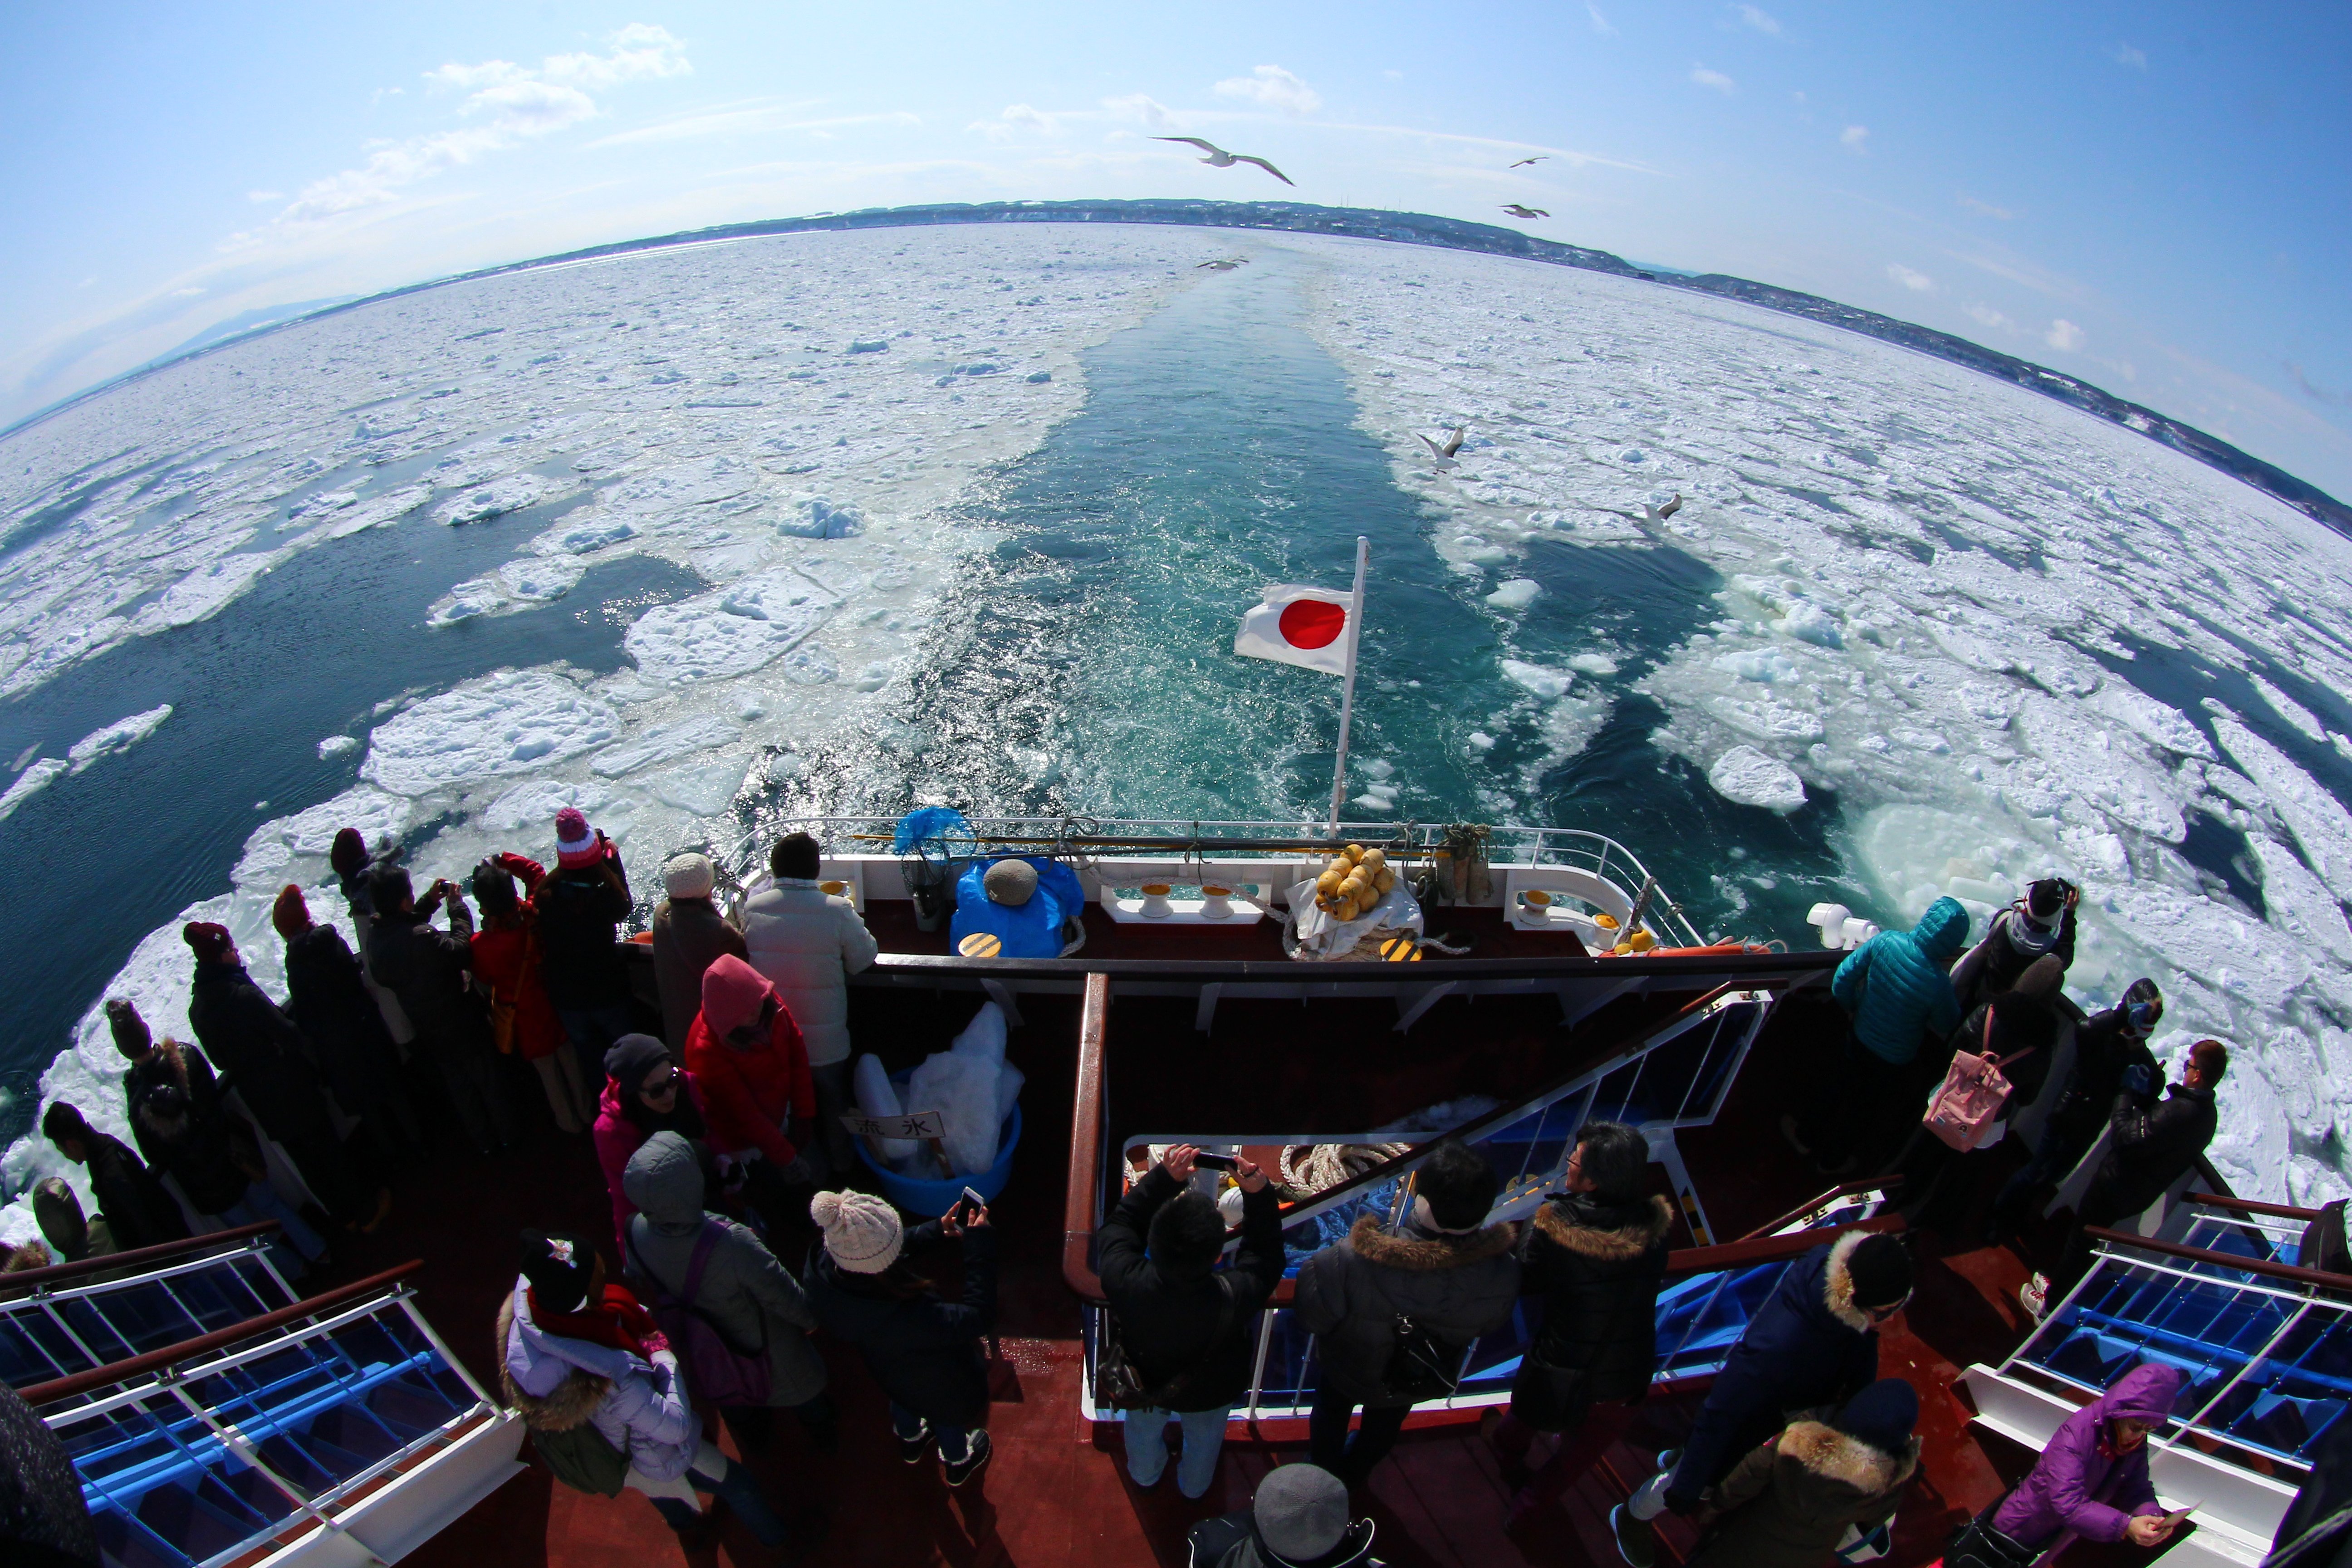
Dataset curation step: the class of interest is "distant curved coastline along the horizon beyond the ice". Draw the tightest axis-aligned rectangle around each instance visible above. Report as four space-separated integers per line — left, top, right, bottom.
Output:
0 200 2352 536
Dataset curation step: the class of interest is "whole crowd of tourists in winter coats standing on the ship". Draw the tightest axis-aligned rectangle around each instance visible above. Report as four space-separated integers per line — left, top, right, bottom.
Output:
12 841 2227 1568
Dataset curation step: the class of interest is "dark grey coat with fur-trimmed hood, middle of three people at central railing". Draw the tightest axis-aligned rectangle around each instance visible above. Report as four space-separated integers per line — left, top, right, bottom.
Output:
1294 1215 1519 1406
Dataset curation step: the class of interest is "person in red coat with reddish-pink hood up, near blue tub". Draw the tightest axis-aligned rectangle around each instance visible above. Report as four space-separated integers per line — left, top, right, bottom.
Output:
687 952 823 1225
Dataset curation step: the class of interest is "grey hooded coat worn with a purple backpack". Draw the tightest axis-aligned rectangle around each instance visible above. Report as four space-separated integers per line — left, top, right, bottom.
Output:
621 1133 826 1406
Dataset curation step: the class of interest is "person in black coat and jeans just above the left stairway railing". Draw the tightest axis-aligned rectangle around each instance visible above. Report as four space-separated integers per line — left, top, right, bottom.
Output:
106 997 327 1267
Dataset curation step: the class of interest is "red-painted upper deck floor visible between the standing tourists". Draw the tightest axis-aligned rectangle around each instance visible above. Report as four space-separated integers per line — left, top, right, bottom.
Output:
303 968 2069 1568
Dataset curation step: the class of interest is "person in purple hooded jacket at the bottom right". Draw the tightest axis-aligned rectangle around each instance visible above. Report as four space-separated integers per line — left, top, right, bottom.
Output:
1992 1361 2180 1563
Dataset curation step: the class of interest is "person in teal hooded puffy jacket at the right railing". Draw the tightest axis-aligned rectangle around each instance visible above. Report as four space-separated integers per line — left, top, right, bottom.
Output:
1780 898 1969 1173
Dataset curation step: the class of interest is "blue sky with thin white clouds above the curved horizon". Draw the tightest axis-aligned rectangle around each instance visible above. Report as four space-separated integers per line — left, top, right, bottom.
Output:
0 0 2352 496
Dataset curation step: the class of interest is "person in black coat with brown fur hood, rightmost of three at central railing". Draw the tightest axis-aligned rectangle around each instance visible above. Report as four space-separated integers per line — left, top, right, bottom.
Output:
1494 1122 1675 1512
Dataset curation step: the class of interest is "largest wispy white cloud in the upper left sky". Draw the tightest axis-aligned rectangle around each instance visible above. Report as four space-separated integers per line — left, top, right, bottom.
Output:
242 21 694 251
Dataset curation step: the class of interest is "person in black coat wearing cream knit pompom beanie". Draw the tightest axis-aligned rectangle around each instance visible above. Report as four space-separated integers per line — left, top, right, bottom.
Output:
807 1192 997 1486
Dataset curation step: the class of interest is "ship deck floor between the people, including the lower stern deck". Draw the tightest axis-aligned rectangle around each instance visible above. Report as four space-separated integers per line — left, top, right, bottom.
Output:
308 905 2091 1568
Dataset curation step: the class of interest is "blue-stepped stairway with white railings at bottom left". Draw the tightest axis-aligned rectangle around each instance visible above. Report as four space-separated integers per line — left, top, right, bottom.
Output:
0 1225 522 1568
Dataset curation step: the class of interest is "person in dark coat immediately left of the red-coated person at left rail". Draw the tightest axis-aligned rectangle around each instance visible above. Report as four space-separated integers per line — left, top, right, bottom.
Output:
367 865 515 1154
